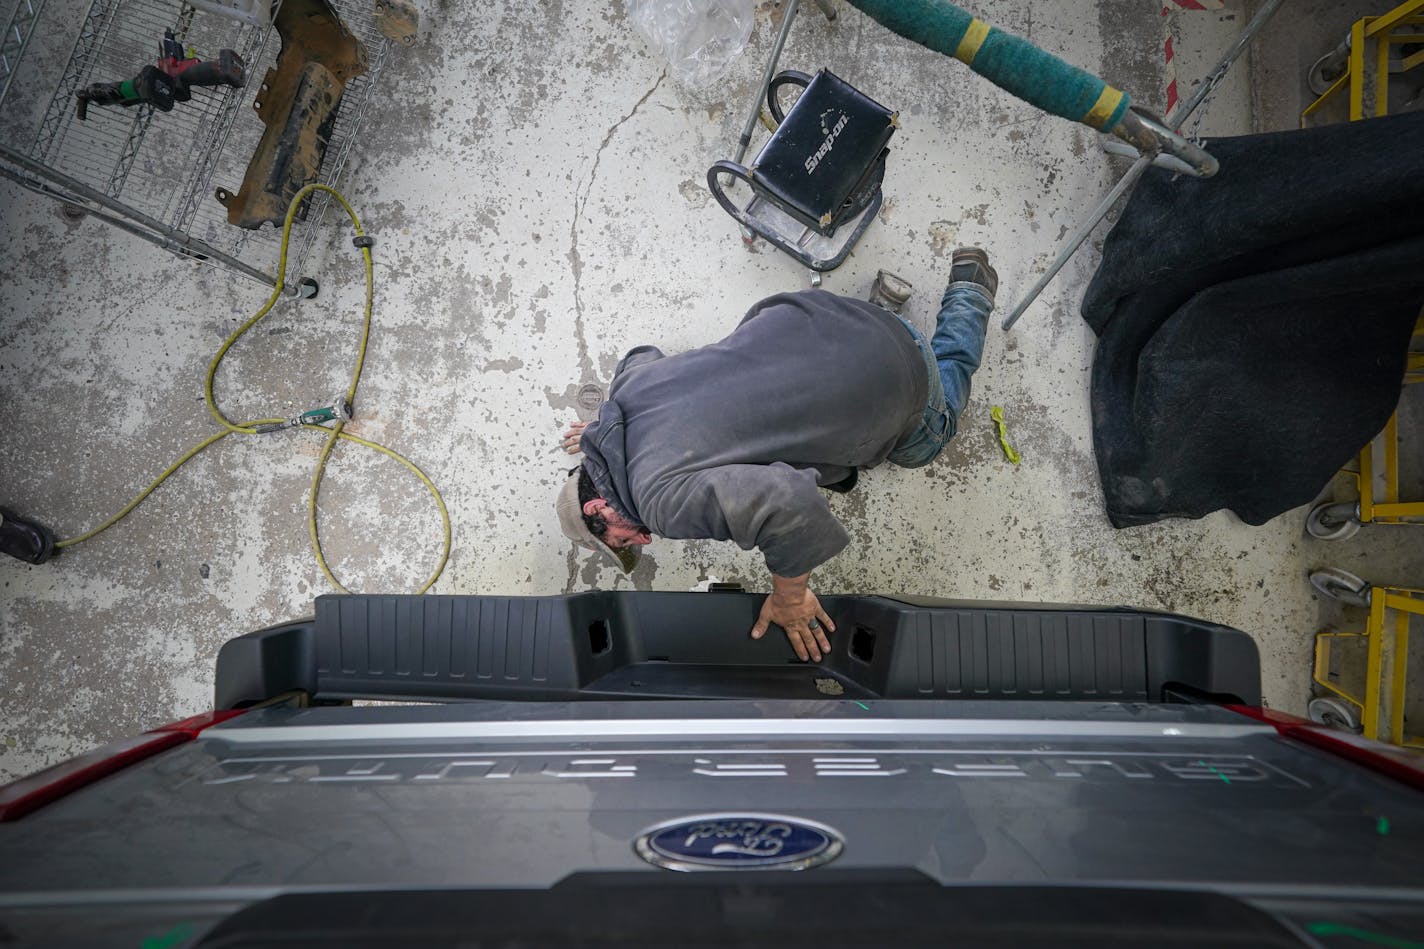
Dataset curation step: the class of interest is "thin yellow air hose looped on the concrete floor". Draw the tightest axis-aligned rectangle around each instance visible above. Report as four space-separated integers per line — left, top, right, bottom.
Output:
54 184 450 593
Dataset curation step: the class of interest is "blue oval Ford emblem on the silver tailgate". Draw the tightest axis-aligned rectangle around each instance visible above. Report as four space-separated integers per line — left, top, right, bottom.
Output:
634 814 844 871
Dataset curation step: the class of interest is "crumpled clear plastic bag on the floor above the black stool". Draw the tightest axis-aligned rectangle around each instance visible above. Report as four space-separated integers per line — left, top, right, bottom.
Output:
628 0 755 88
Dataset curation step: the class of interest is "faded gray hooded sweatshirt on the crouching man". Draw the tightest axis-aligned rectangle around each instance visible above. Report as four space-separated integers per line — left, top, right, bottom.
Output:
582 291 928 577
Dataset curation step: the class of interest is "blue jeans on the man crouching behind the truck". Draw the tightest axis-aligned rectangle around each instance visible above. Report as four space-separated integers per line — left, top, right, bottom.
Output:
887 281 994 467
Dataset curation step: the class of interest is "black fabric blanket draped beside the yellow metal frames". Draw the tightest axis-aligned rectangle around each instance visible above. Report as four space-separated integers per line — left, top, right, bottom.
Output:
1082 113 1424 527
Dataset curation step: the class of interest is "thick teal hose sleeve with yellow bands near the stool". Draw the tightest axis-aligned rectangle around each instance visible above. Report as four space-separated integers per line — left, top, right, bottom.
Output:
850 0 1131 133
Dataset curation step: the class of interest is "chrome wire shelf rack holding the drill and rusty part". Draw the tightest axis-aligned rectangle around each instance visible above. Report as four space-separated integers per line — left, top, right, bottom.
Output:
0 0 390 292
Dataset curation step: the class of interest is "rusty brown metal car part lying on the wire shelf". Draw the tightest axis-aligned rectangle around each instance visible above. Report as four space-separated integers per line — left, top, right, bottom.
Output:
216 0 366 228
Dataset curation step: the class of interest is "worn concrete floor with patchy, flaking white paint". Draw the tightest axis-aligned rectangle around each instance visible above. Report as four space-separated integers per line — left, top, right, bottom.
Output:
0 0 1424 778
